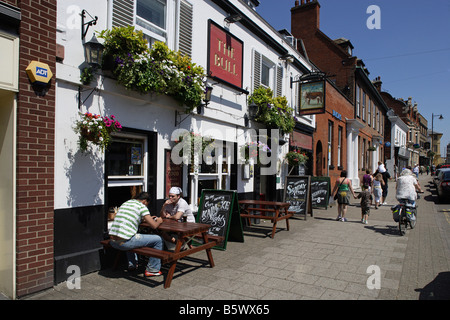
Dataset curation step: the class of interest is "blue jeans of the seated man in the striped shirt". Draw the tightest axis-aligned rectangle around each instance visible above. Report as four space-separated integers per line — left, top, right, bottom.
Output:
110 233 164 272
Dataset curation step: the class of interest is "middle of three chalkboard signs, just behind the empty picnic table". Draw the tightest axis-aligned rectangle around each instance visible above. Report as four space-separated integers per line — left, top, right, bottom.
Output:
284 176 312 220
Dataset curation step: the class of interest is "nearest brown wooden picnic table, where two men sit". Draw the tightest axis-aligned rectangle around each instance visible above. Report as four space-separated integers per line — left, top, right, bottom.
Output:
101 219 221 288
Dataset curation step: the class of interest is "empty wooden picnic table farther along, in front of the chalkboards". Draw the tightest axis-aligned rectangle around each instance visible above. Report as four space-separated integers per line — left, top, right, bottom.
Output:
239 200 293 239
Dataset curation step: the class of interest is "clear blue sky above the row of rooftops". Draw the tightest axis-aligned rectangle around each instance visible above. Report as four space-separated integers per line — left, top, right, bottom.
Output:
256 0 450 156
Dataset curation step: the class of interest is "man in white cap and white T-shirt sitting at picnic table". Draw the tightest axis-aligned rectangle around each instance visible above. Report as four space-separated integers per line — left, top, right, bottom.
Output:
160 187 195 222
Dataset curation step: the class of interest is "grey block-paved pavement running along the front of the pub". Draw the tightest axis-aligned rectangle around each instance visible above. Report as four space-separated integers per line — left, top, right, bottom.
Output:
19 172 450 300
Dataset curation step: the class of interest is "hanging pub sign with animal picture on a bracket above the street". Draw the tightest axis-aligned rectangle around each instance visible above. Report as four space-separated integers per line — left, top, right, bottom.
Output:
299 80 325 115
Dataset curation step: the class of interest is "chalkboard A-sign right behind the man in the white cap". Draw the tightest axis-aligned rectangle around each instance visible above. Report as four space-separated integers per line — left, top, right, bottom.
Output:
197 189 244 250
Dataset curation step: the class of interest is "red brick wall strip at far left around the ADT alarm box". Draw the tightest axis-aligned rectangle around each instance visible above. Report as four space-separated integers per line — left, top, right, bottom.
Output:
6 0 56 297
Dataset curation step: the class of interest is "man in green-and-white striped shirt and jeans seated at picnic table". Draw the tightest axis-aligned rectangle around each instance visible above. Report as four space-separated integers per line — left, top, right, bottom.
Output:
109 192 163 277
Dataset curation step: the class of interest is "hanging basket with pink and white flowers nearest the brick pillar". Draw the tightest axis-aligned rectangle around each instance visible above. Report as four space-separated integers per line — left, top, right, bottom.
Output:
74 112 122 152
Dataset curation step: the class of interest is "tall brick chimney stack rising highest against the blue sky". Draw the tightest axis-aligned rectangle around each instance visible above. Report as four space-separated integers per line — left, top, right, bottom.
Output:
291 0 320 38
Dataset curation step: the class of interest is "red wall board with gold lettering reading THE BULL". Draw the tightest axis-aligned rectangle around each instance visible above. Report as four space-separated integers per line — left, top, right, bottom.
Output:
208 20 244 88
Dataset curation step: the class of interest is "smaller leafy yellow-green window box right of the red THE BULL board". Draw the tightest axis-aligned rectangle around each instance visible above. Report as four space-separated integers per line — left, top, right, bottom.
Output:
248 87 297 134
